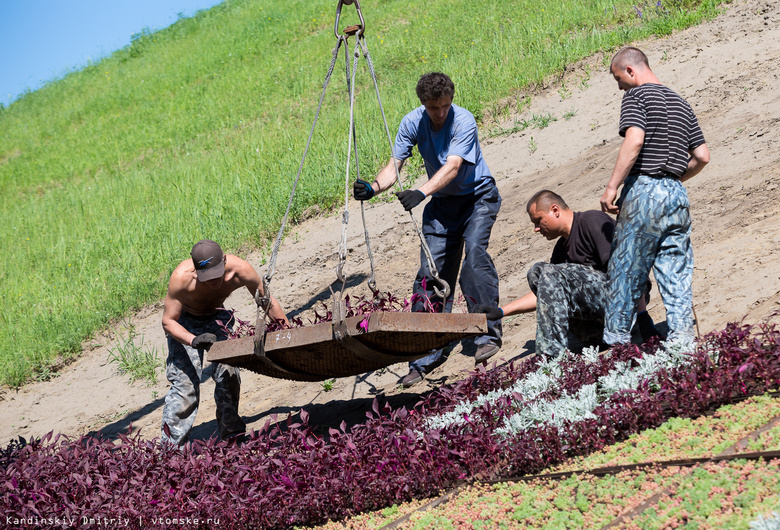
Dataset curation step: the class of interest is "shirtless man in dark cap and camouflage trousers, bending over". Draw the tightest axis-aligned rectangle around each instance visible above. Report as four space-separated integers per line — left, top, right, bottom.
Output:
161 239 287 445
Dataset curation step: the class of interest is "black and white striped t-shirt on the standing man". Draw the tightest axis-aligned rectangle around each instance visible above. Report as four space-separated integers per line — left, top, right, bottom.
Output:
620 83 704 178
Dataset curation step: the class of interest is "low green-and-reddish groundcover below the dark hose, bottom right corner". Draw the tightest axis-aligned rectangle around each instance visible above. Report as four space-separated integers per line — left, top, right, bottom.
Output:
388 459 780 530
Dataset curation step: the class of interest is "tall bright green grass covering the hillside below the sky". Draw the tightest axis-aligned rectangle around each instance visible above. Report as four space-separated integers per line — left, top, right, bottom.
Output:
0 0 718 386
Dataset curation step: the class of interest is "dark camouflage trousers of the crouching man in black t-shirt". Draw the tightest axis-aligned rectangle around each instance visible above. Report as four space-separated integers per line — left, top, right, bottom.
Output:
528 263 607 357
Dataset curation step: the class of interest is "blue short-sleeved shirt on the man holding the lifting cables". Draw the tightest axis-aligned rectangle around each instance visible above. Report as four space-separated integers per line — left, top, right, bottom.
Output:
393 104 494 197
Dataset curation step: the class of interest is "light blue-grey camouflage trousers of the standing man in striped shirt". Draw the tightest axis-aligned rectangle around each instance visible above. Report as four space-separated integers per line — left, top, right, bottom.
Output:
604 175 694 344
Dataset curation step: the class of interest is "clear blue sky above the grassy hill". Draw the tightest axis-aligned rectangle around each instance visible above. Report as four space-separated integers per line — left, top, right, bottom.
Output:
0 0 221 106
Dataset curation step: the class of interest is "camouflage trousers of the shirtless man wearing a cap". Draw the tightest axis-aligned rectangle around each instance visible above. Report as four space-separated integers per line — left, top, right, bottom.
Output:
160 310 246 445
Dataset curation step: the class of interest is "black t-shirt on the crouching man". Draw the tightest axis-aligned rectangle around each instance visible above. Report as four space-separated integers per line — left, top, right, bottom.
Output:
550 210 615 272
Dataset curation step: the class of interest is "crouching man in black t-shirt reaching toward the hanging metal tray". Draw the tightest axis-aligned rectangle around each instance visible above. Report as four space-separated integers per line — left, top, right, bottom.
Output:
474 190 659 357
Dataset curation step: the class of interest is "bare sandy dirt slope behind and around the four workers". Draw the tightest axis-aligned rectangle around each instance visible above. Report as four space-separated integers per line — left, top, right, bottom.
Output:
0 0 780 444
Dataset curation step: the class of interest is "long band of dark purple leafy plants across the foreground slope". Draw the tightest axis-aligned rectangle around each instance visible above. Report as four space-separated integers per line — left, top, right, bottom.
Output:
0 324 780 528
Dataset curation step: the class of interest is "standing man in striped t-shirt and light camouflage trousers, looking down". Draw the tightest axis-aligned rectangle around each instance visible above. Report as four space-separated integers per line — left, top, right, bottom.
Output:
601 47 710 344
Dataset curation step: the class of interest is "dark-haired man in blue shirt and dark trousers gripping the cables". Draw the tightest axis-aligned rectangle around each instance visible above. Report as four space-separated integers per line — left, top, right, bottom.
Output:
354 72 501 387
